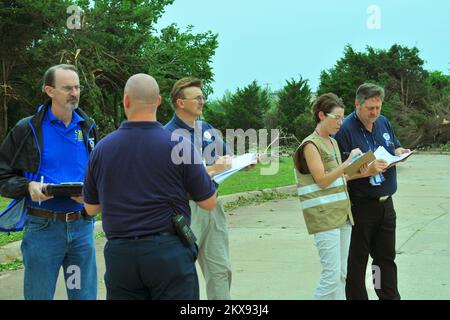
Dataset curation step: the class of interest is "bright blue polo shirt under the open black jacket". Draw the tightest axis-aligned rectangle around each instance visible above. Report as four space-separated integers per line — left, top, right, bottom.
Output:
27 108 89 212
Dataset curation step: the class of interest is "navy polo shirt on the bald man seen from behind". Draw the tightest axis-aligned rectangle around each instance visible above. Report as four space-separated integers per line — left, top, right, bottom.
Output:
83 121 216 238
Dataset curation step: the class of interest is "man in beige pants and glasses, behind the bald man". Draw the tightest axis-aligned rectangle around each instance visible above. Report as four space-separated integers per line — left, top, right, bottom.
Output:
165 78 236 300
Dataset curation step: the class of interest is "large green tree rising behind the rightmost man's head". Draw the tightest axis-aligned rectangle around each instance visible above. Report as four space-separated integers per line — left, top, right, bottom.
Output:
318 44 433 147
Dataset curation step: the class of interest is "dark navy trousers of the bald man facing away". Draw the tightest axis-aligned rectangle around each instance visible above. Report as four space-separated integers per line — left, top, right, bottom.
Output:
104 235 199 300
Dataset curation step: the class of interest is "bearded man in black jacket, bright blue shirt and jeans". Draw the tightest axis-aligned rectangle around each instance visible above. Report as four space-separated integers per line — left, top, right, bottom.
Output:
0 64 97 300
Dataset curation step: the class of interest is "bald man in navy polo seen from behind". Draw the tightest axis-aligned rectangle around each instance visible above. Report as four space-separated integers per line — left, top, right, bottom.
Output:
83 74 216 300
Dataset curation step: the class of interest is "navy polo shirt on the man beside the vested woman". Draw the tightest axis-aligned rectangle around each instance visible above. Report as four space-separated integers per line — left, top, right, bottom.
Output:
334 111 401 197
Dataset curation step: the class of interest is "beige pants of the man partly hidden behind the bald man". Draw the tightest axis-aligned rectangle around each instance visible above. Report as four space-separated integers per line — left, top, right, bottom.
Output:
189 198 231 300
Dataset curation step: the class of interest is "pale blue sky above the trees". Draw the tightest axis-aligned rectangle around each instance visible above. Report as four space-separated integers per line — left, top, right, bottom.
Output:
157 0 450 98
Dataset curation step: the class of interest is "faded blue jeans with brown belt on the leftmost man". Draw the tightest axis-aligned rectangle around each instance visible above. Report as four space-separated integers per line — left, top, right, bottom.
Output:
21 215 97 300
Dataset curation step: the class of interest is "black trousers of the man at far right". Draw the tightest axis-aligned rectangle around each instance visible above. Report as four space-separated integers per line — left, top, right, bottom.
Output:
345 197 400 300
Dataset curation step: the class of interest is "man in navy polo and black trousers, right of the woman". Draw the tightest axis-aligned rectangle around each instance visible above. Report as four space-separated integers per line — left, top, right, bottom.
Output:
335 83 409 300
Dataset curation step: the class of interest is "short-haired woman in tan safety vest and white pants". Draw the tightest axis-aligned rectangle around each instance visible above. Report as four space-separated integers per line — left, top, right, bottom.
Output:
294 93 367 300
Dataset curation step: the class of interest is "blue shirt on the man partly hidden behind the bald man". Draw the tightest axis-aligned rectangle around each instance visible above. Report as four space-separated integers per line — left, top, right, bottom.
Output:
164 114 230 166
